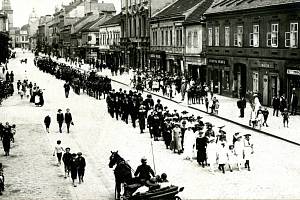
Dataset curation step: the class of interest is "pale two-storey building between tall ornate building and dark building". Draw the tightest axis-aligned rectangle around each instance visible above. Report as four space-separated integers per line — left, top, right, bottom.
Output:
150 0 212 76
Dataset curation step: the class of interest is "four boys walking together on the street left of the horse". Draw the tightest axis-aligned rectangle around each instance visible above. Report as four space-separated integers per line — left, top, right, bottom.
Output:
53 140 86 187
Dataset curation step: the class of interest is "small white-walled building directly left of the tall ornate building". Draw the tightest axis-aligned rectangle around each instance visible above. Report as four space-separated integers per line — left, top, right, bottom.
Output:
99 14 121 68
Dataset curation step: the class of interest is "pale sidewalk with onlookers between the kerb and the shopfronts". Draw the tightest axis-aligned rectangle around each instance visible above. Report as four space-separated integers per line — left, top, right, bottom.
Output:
48 58 300 146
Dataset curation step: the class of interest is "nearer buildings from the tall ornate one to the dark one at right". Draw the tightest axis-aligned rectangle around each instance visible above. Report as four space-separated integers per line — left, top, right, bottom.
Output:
120 0 300 105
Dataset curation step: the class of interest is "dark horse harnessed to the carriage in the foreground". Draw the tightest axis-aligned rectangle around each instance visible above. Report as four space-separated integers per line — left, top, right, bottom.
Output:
108 151 133 199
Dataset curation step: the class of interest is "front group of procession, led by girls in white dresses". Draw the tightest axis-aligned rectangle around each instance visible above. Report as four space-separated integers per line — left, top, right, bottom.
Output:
106 89 253 173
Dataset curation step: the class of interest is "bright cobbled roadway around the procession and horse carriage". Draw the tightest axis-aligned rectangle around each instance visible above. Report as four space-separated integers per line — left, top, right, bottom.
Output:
0 50 300 200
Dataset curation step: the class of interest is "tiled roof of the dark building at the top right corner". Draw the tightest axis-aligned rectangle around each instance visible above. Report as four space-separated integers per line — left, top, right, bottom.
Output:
205 0 300 14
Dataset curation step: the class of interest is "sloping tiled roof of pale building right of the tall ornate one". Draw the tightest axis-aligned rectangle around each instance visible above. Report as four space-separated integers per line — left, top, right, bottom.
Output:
153 0 202 19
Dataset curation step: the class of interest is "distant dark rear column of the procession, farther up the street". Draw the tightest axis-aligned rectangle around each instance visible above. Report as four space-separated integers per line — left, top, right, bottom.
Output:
35 57 111 99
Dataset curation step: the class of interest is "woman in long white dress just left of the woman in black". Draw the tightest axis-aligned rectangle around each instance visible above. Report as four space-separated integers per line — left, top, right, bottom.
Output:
183 125 196 160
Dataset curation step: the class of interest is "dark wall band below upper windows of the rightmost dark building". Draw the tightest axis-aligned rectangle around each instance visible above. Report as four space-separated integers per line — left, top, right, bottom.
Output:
206 46 300 59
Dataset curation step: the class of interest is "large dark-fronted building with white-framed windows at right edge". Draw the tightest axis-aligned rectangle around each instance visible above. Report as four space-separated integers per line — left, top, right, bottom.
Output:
205 0 300 105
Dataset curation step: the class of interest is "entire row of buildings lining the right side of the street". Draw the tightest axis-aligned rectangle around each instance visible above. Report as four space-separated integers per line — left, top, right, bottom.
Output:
6 0 300 105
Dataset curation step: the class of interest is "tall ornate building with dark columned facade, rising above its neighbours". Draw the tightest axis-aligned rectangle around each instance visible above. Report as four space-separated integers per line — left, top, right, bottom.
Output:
121 0 174 69
